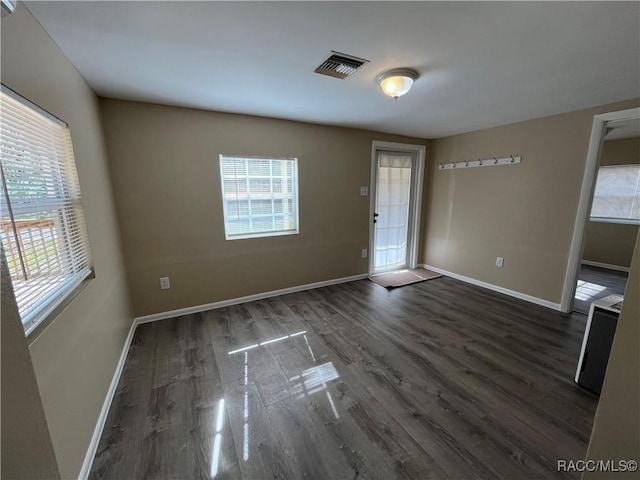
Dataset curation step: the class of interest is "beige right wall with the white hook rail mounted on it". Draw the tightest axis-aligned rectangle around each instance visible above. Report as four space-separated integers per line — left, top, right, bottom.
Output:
421 99 640 304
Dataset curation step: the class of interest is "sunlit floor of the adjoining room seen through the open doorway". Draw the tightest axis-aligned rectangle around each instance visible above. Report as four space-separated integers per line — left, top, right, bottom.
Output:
573 265 629 315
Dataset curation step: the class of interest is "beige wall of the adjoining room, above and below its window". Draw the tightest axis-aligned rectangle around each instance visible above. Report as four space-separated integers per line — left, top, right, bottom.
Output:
582 138 640 267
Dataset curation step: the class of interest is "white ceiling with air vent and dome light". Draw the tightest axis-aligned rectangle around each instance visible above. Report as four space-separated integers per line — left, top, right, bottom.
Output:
27 1 640 138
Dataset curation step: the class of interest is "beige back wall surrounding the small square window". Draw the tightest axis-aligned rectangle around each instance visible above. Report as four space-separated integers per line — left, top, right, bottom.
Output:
101 99 425 315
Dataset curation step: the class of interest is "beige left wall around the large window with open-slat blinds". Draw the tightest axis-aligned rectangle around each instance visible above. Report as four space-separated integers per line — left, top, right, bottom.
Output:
2 2 133 478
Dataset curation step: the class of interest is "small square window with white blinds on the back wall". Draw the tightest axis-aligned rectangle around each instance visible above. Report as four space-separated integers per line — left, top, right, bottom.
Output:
220 155 298 240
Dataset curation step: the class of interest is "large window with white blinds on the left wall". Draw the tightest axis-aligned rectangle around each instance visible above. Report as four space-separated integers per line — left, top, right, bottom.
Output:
0 85 91 334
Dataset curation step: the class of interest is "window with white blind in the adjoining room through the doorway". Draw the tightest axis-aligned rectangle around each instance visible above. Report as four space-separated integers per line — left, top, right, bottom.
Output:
591 165 640 223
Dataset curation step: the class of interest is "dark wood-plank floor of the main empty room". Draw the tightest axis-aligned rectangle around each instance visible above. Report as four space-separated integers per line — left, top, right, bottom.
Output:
91 277 597 480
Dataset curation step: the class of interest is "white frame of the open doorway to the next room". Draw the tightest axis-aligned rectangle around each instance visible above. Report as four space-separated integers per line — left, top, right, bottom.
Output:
560 108 640 313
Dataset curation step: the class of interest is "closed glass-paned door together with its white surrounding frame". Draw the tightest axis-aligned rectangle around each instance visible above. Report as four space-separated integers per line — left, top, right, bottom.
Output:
369 141 426 275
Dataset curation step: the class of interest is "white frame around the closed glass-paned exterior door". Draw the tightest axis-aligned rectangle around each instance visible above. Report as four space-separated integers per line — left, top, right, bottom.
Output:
369 140 427 274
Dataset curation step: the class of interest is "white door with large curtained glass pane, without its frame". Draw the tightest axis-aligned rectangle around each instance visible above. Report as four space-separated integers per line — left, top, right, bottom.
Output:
371 151 416 274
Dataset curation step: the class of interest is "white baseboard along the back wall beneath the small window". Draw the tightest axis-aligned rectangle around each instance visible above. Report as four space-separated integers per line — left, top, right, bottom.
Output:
136 273 368 324
